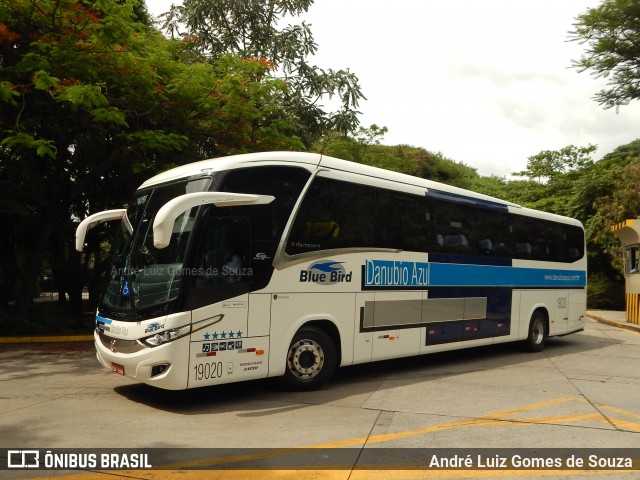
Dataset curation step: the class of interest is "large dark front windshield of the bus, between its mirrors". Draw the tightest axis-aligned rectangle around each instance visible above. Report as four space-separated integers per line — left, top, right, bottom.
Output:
101 178 211 317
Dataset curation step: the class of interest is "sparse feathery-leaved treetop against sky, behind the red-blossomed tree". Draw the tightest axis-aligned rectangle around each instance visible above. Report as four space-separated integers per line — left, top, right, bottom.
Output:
163 0 364 142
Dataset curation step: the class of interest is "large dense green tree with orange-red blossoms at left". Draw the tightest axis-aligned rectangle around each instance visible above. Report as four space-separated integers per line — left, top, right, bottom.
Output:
0 0 301 330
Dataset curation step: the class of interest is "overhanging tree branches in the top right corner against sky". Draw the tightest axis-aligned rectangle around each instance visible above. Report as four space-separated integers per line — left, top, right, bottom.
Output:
571 0 640 108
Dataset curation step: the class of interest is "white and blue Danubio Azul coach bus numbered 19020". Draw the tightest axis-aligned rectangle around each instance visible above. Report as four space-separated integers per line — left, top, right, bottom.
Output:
76 152 587 390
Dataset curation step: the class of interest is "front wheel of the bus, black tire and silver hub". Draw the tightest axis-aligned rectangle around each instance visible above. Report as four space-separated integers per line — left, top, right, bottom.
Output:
280 326 337 392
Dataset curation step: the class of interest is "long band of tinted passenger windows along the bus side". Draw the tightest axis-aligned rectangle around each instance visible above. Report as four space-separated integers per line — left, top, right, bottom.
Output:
286 177 584 262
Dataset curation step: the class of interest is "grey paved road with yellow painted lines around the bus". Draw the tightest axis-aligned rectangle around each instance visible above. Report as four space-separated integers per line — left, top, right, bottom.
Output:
0 320 640 480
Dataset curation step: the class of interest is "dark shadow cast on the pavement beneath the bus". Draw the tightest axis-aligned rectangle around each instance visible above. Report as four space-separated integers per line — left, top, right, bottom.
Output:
114 333 621 417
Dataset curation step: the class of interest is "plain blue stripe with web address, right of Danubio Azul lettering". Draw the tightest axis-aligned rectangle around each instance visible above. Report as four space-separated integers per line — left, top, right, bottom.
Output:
429 263 587 288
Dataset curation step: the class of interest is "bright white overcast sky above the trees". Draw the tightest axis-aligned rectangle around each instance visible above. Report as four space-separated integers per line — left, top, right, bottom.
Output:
146 0 640 178
